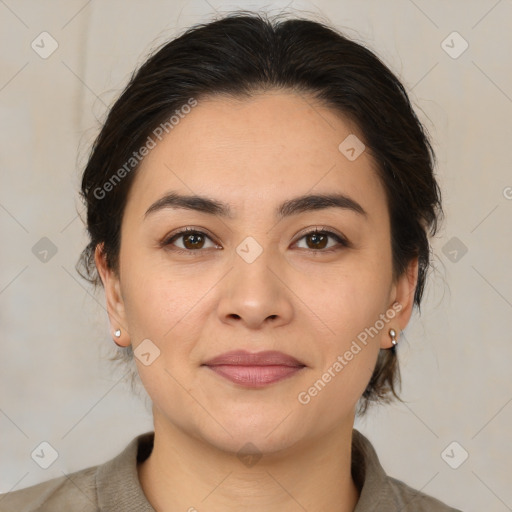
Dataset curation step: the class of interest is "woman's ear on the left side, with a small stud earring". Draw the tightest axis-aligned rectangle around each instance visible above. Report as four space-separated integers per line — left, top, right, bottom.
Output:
94 243 130 347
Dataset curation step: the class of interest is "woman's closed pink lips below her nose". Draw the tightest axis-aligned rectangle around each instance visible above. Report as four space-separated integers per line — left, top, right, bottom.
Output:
204 350 305 388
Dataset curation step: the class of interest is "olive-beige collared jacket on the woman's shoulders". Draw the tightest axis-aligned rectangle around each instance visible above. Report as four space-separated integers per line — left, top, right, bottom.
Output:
0 429 461 512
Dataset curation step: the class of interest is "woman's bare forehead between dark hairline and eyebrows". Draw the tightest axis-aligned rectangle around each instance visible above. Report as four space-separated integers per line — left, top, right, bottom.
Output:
127 92 386 220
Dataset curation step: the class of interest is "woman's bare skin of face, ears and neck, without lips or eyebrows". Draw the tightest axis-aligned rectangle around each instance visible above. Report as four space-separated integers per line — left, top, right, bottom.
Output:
95 91 417 512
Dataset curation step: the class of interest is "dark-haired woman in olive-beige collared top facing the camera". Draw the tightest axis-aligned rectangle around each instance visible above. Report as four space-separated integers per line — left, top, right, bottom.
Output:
0 12 464 512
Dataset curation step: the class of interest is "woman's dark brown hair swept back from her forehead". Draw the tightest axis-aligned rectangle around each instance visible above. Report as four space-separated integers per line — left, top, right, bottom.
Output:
77 11 443 414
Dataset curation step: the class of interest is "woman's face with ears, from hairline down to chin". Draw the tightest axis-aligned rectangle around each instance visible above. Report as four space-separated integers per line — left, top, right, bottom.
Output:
96 92 416 452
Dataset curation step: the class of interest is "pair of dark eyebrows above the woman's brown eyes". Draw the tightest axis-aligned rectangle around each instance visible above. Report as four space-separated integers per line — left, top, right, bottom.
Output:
144 192 368 219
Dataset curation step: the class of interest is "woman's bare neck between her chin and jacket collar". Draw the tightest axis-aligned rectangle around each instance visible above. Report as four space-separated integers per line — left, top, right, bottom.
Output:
138 410 359 512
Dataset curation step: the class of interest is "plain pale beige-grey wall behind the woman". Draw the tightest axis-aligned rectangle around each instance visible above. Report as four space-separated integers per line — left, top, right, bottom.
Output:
0 0 512 512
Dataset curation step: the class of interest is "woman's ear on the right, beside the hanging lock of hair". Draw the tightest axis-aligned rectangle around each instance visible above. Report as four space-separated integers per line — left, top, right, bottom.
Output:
381 257 419 348
